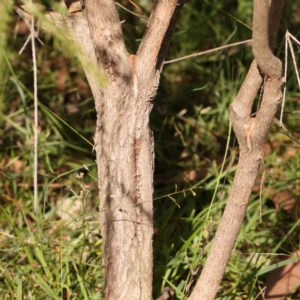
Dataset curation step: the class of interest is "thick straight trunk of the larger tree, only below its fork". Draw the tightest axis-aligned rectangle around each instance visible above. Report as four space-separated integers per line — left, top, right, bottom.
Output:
95 73 154 299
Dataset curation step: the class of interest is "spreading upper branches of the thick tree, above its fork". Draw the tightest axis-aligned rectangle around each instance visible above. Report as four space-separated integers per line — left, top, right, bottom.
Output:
15 0 187 98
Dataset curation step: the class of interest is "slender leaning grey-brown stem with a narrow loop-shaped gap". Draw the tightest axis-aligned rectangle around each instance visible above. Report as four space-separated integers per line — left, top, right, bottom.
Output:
189 0 283 300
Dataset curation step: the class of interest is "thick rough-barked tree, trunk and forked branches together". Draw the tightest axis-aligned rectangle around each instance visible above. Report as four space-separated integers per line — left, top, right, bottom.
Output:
16 0 186 300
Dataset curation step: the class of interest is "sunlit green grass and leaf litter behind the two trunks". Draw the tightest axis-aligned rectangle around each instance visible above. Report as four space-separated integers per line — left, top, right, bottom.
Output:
0 0 300 299
